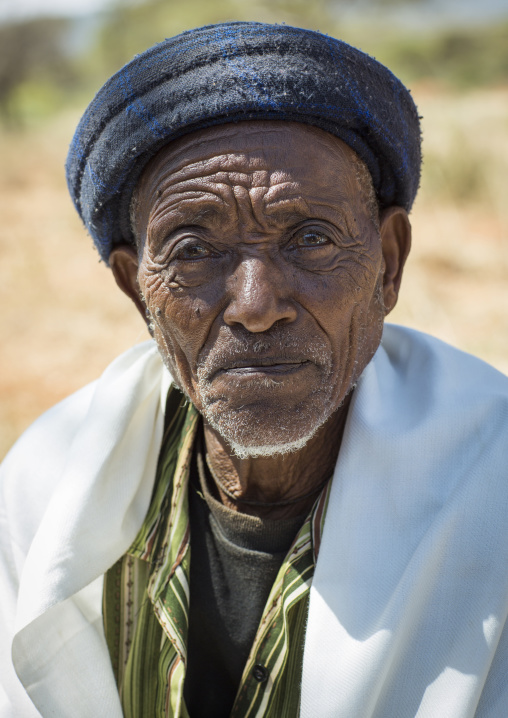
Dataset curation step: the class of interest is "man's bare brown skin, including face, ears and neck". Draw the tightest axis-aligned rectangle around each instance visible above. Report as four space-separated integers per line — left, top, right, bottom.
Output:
110 121 411 519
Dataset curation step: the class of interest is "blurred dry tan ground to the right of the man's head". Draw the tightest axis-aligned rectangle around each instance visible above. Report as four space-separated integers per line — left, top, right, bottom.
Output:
390 88 508 373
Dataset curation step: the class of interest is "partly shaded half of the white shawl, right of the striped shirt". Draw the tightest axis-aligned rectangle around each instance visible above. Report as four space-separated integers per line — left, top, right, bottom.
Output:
301 327 508 718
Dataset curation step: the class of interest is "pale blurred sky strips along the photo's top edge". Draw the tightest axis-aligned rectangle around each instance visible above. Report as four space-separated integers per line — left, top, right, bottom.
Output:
0 0 508 22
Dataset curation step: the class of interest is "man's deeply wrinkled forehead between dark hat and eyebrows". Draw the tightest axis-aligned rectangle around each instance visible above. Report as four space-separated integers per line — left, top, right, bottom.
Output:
133 121 368 240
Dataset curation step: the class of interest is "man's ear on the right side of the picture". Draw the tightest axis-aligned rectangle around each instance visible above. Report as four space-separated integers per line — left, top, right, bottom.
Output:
379 207 411 314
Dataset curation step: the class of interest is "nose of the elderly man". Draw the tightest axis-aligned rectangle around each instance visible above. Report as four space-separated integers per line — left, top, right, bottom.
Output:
224 257 297 332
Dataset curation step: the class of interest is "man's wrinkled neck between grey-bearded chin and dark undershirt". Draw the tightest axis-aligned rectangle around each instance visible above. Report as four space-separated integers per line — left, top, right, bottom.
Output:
204 395 351 519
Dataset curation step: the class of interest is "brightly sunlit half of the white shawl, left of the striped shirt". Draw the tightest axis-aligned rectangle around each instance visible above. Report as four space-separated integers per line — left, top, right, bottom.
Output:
0 342 169 718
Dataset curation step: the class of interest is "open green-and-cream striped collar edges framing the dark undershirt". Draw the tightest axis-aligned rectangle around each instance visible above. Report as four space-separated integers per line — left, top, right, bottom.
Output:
128 390 331 718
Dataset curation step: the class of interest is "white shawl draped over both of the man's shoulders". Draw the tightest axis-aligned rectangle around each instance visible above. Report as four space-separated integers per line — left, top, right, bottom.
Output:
0 326 508 718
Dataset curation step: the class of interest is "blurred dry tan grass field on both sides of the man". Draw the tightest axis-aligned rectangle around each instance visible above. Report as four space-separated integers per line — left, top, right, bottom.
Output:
0 86 508 457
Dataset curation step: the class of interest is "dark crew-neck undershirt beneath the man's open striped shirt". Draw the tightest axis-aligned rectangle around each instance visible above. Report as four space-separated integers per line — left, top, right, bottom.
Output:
184 442 306 718
